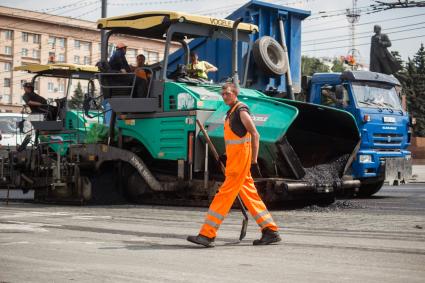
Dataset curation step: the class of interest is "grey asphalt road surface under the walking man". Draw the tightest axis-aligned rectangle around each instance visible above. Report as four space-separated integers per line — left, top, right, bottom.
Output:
0 184 425 283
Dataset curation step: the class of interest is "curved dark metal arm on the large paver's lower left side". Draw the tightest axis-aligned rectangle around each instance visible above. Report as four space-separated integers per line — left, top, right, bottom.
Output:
71 144 168 191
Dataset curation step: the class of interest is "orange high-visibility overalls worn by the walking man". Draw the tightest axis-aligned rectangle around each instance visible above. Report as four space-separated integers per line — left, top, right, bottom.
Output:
199 102 278 238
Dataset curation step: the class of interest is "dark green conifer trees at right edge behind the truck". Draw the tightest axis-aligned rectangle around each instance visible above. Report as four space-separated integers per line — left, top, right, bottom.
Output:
392 44 425 137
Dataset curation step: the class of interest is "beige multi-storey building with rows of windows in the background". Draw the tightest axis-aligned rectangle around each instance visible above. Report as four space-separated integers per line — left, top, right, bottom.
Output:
0 6 174 112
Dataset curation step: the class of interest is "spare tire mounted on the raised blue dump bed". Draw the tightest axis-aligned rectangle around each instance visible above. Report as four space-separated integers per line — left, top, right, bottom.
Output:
252 36 288 76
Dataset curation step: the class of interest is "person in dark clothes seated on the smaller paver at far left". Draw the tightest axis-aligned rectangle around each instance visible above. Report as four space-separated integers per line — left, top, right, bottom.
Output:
22 83 58 121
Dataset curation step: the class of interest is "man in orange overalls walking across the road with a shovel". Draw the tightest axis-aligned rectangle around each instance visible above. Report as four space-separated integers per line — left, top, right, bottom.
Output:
187 83 281 247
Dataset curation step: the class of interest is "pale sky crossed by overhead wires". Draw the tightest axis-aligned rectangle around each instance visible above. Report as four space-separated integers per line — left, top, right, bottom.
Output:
0 0 425 64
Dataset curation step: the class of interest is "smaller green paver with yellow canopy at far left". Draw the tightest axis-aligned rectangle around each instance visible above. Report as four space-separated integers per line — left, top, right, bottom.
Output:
0 63 103 202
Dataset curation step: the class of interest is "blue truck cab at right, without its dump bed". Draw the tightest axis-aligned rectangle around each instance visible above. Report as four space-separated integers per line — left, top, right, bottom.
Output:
307 71 412 196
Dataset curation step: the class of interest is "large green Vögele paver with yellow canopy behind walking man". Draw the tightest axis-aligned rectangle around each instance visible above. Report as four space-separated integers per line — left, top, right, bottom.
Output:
4 11 359 205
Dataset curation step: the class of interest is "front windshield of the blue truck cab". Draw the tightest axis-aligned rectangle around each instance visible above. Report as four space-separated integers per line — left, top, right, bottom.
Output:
353 82 401 110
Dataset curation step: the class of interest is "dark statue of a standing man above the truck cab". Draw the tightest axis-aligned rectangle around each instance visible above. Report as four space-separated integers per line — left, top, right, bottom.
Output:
369 25 401 75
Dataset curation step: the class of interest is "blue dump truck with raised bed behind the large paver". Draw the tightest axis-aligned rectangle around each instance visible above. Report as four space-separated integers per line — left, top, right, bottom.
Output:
168 0 411 196
